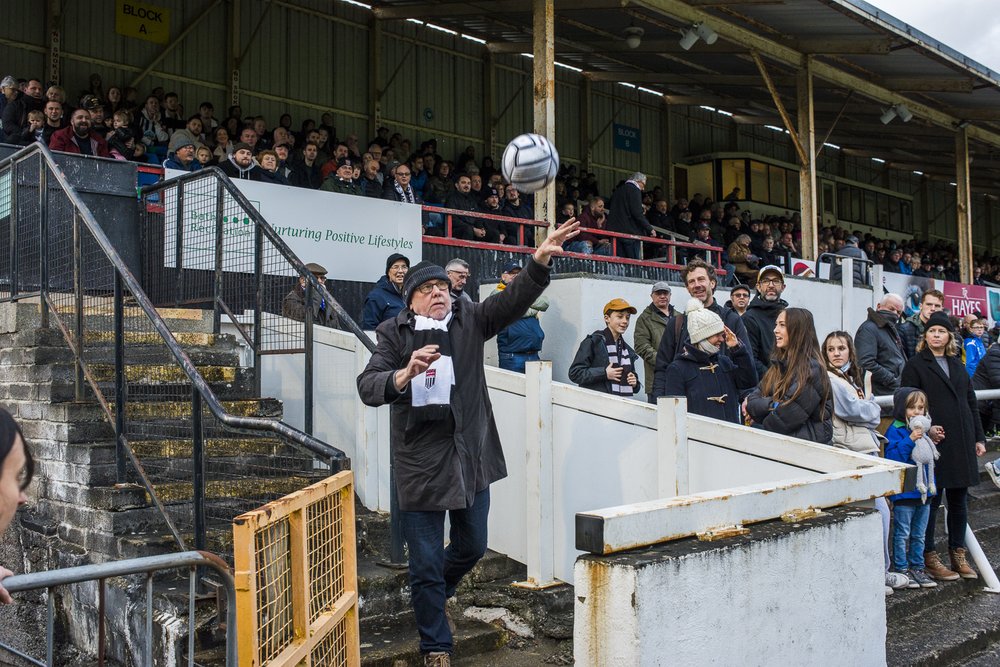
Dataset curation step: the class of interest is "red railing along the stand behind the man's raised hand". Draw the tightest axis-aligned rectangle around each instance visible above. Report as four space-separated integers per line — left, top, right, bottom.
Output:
423 205 725 275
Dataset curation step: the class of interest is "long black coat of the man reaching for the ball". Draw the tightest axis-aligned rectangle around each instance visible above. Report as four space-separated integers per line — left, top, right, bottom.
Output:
358 260 550 511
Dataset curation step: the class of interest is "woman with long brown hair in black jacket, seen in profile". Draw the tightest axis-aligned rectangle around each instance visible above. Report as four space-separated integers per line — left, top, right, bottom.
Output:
744 308 833 445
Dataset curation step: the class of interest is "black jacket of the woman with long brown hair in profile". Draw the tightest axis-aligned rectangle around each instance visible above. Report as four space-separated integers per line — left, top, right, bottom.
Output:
747 361 833 445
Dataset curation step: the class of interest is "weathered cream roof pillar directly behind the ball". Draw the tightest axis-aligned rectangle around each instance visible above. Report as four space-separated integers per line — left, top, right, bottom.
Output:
532 0 556 243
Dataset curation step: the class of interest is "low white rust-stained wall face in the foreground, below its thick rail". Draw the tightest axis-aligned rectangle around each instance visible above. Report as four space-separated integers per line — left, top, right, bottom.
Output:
573 510 886 667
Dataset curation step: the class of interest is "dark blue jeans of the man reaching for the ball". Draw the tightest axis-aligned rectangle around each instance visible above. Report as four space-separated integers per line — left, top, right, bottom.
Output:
399 487 490 653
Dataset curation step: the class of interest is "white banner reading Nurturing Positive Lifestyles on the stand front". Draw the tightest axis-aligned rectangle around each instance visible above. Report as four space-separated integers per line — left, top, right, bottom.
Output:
163 170 422 282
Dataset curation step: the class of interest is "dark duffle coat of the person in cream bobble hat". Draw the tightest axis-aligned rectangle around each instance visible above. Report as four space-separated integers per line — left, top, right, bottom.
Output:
665 343 757 424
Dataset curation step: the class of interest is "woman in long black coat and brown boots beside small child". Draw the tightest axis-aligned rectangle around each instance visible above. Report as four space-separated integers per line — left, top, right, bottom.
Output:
900 312 986 581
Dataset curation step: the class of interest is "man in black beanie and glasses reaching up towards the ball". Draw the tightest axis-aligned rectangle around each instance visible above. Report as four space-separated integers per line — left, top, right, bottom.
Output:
358 220 579 667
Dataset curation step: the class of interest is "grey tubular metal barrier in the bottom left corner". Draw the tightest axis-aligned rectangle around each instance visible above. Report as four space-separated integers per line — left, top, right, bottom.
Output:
0 551 238 667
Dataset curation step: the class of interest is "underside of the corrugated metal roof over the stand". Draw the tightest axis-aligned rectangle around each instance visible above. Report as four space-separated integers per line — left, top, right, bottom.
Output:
376 0 1000 187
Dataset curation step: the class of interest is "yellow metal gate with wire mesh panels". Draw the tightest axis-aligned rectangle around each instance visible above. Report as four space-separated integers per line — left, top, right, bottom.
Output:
233 471 361 667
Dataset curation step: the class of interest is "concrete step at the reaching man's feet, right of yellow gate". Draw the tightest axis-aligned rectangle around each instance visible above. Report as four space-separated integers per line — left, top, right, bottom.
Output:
361 612 506 667
